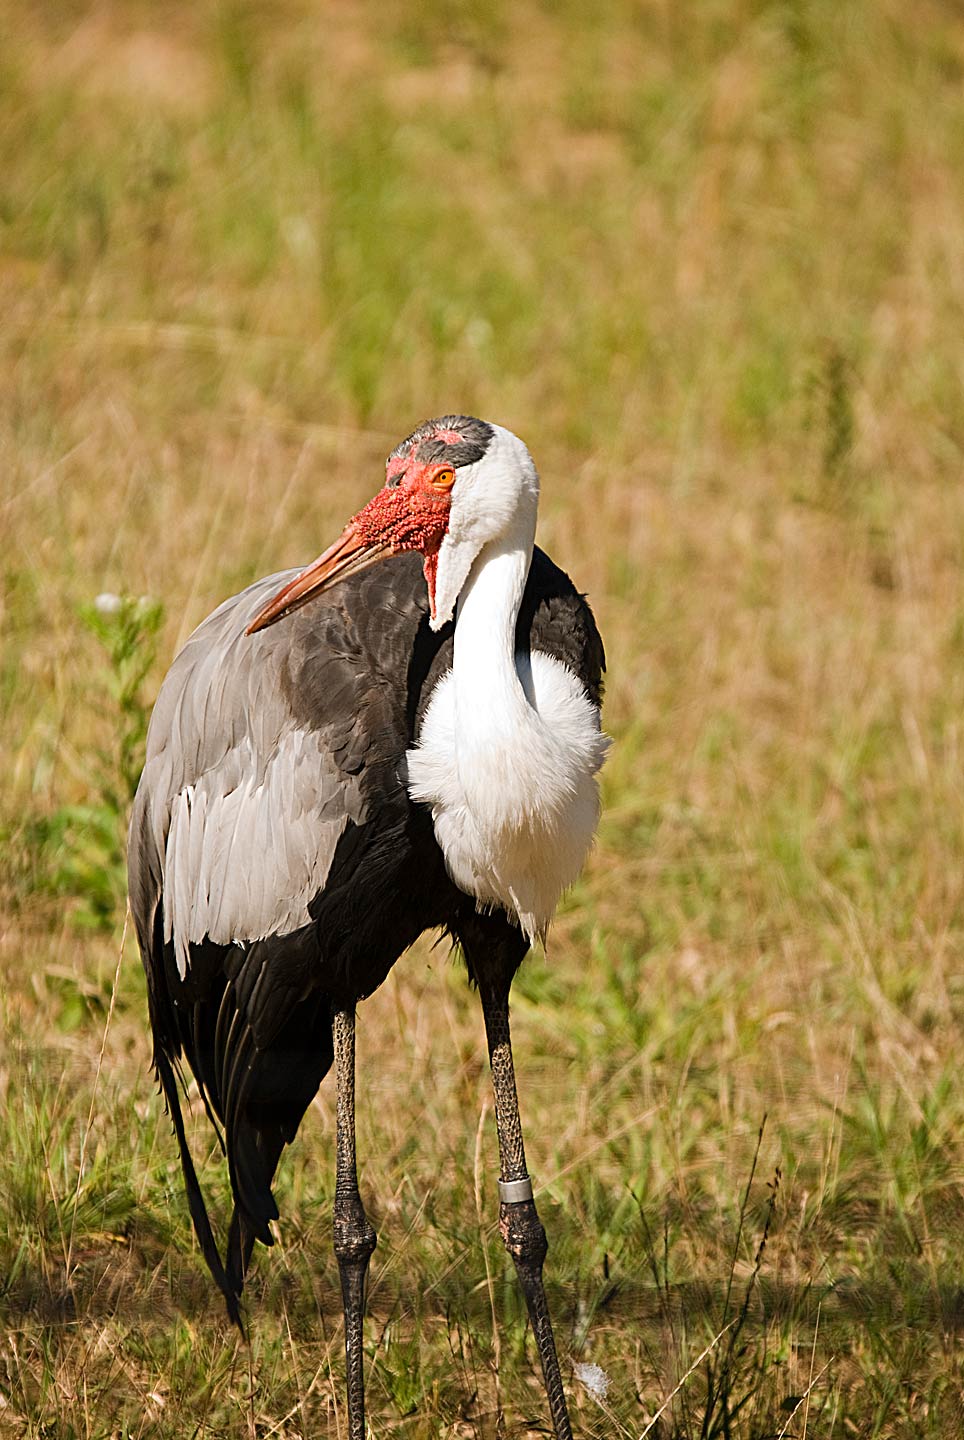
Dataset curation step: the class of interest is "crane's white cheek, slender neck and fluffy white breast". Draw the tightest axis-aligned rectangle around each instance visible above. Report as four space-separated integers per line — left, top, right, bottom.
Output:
408 428 605 939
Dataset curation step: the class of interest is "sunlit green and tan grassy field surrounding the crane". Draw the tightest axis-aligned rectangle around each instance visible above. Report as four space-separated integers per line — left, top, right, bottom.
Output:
0 0 964 1440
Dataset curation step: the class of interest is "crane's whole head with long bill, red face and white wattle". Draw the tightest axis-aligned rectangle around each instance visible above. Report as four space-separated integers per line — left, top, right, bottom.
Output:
248 415 539 635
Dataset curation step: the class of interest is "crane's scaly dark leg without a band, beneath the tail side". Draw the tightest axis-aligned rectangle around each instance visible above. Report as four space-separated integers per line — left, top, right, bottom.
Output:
331 1009 375 1440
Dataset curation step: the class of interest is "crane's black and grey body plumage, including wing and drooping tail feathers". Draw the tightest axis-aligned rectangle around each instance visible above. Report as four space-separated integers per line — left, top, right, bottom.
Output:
130 550 604 1319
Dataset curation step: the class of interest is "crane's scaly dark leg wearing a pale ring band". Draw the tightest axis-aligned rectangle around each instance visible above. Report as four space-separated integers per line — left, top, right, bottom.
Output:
483 989 572 1440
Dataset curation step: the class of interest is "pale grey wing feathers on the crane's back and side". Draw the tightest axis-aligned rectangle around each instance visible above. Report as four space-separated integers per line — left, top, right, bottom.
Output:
131 572 357 979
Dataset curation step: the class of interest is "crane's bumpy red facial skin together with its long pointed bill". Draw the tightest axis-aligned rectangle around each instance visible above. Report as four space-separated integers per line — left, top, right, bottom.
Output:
246 456 452 635
